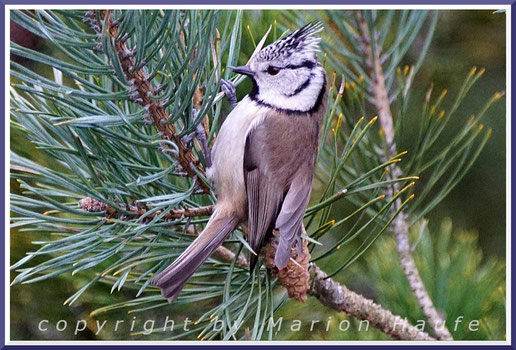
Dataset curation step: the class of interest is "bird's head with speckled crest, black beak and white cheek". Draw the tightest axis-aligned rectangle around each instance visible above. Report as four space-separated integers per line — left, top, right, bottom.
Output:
233 22 326 113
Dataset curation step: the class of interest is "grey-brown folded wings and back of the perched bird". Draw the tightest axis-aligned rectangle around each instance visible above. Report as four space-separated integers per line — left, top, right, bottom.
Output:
244 117 313 269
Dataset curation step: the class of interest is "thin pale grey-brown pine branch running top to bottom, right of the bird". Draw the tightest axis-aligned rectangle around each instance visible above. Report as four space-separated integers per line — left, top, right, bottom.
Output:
358 11 453 340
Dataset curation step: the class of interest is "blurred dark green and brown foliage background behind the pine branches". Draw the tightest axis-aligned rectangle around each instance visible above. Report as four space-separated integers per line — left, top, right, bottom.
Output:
11 10 507 340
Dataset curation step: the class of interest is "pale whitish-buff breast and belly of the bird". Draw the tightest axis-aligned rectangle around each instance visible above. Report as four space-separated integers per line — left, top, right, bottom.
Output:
207 96 266 214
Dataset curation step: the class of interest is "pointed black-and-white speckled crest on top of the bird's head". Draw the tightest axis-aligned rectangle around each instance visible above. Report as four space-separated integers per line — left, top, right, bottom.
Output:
256 22 323 61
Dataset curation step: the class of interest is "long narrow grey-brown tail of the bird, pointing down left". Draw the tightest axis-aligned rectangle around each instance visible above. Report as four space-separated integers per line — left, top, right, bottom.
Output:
151 213 238 303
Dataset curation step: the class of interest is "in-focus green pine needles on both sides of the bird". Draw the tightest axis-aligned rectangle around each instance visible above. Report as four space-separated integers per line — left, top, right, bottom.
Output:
10 10 502 340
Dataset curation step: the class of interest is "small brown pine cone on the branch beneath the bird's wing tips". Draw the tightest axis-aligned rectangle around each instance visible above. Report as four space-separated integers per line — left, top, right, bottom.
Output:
260 231 310 303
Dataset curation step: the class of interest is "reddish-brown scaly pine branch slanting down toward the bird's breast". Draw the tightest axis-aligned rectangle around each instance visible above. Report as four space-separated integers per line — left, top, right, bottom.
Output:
86 10 209 193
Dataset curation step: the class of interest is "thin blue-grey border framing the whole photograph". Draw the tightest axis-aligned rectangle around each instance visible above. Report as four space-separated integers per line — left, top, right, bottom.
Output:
0 0 516 350
